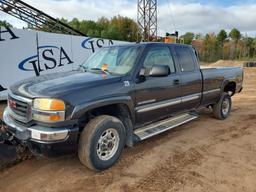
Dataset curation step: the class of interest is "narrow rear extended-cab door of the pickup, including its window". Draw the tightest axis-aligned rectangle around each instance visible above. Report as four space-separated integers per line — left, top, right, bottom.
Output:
174 45 202 110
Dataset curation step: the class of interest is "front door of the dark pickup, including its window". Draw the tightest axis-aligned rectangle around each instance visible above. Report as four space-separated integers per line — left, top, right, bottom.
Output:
135 45 181 125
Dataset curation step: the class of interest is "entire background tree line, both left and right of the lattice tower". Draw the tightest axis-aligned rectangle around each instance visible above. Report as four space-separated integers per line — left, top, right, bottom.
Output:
0 18 256 62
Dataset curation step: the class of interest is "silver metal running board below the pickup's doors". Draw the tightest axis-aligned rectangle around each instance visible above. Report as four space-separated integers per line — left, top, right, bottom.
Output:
134 112 198 141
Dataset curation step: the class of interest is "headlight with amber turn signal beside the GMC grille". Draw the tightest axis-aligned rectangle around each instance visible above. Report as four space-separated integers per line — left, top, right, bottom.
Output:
32 98 65 123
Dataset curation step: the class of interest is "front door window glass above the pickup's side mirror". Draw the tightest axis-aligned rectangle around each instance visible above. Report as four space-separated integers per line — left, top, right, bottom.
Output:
143 47 175 73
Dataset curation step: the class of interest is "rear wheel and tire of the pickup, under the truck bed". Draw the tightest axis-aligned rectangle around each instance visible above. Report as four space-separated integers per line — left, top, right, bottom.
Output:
212 92 232 120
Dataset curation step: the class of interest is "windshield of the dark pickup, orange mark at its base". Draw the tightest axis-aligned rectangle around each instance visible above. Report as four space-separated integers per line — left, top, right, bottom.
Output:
82 46 140 75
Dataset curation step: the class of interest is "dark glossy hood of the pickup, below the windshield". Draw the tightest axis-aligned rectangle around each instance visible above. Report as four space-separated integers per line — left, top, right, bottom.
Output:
10 71 121 98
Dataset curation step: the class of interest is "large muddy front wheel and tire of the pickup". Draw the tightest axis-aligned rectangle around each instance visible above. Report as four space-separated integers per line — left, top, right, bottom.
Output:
78 115 126 171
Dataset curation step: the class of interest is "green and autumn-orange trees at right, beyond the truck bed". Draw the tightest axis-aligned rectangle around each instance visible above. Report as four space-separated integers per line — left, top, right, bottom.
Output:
181 28 256 62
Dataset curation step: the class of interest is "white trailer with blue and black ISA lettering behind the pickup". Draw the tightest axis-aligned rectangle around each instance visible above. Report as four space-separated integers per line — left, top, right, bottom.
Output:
0 27 125 100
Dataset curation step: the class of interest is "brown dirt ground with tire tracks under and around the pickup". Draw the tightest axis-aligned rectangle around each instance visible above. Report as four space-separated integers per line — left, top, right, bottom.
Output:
0 61 256 192
